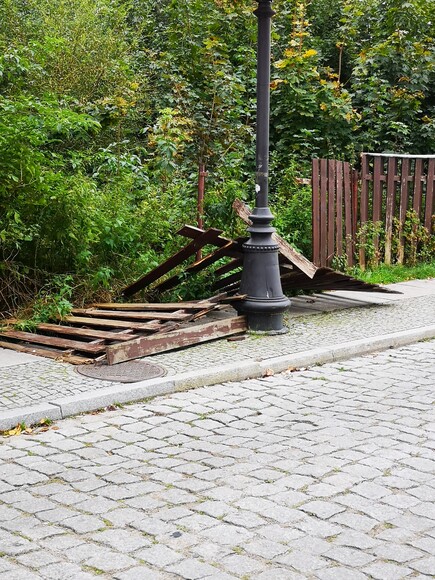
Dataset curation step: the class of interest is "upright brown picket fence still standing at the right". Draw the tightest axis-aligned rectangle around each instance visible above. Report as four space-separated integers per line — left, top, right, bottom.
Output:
312 153 435 268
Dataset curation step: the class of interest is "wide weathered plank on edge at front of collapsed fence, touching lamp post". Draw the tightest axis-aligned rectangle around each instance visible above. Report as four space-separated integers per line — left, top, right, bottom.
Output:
106 316 248 365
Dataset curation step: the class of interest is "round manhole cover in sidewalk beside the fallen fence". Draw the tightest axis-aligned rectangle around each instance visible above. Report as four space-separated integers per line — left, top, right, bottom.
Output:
75 360 166 383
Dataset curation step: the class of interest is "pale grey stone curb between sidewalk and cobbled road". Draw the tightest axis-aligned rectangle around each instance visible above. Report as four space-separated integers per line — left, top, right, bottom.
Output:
0 325 435 431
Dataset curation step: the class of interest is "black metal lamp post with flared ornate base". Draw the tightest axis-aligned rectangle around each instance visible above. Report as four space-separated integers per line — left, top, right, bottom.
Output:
239 0 290 332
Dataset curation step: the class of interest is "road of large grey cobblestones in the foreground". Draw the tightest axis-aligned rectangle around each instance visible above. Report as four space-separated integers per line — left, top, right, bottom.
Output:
0 341 435 580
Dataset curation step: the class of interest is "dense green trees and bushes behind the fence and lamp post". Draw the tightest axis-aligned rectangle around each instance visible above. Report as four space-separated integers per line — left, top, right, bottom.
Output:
0 0 435 311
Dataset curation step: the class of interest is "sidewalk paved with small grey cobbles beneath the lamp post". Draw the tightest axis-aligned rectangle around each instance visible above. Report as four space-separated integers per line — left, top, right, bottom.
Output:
0 295 435 412
